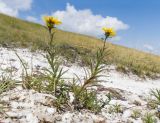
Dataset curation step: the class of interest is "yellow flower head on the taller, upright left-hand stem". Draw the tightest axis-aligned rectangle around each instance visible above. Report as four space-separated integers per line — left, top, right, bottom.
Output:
43 16 62 29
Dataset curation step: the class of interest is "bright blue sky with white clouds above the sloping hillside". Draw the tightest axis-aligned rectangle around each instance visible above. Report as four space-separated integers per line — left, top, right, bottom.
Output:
0 0 160 54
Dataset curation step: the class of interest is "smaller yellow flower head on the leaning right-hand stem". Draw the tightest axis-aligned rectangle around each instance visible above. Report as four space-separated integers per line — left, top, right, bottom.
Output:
102 27 116 38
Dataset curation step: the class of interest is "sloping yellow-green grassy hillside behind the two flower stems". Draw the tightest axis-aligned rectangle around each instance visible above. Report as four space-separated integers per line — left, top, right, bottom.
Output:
0 14 160 78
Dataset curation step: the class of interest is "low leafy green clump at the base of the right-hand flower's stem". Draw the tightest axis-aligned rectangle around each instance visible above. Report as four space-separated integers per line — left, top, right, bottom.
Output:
71 81 111 113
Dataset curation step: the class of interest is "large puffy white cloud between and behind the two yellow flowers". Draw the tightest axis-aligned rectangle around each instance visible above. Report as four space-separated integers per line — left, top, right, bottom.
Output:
52 3 129 36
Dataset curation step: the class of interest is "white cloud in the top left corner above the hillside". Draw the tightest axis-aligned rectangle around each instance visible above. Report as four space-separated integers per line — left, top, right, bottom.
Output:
0 0 32 16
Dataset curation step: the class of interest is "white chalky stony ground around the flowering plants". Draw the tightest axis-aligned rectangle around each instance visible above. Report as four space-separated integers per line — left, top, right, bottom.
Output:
0 48 160 123
